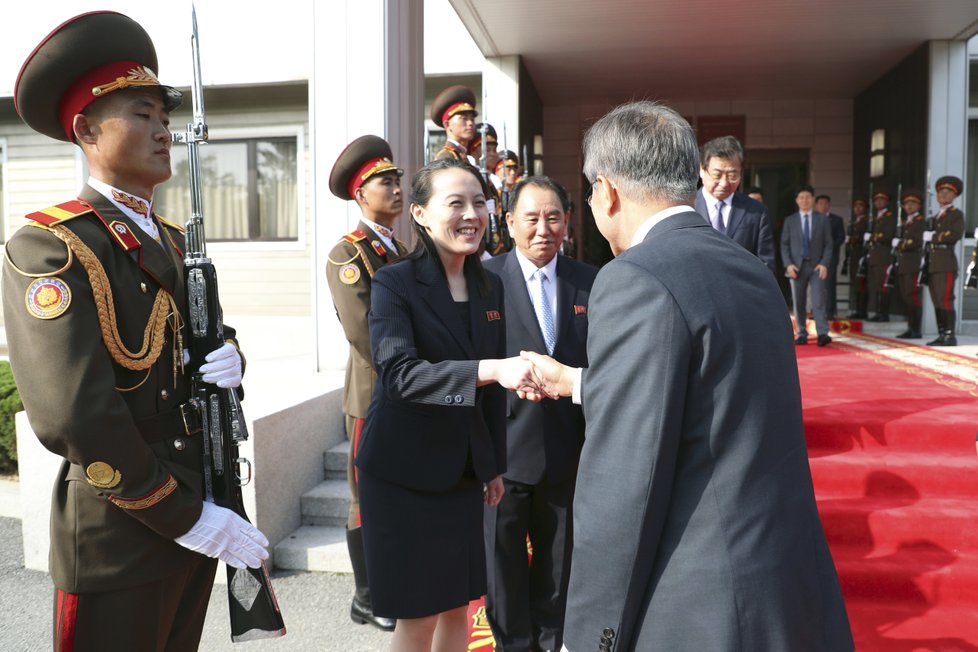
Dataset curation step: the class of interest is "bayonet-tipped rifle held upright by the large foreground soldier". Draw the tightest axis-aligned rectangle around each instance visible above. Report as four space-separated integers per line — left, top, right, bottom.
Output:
173 5 285 643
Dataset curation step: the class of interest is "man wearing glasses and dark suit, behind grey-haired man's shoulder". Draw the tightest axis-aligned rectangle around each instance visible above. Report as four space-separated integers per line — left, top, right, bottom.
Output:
696 136 774 272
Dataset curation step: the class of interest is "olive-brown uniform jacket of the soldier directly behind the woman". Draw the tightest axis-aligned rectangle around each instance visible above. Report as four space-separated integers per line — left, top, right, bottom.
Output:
326 222 407 418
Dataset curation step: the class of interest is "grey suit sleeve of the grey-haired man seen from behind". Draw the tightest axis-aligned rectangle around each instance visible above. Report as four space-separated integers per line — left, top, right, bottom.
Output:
565 261 691 650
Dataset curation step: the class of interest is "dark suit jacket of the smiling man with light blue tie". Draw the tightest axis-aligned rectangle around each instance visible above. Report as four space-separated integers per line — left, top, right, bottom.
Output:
485 250 598 484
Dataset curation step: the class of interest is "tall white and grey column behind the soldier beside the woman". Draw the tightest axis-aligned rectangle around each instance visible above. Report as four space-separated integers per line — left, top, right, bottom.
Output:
309 0 424 371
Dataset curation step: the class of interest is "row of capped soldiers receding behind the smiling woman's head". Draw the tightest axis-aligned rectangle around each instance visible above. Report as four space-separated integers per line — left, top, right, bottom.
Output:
431 85 522 256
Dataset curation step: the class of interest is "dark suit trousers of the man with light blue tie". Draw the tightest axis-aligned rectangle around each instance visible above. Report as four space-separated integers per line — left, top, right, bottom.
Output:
485 475 575 652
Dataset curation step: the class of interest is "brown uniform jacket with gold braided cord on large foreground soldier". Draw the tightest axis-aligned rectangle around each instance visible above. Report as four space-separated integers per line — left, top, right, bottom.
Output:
3 187 230 593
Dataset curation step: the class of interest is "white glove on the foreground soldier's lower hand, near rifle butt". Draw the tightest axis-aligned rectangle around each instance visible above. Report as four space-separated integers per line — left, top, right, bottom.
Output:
174 500 268 568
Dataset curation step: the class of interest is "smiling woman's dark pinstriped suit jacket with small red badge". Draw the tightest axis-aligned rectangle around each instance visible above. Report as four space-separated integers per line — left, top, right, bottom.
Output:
356 258 506 491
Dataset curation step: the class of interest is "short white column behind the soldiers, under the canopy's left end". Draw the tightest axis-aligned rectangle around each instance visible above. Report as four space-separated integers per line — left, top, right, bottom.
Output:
479 54 523 162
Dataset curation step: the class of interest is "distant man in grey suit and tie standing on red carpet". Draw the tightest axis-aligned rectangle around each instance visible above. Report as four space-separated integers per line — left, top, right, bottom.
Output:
781 186 832 346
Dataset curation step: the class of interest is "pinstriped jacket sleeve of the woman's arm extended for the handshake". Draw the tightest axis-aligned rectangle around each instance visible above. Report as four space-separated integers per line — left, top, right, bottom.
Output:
370 265 479 407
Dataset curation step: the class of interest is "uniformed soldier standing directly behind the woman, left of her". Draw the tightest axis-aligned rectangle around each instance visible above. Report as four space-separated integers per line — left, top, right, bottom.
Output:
326 136 407 631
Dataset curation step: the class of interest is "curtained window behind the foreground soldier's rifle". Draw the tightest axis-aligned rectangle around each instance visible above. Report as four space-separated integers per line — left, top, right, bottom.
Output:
156 136 299 242
